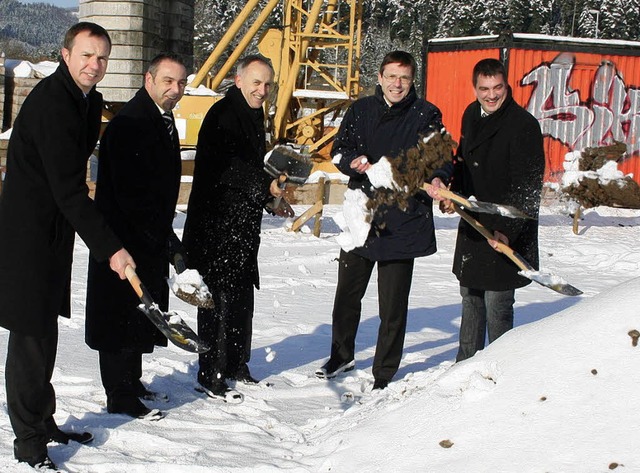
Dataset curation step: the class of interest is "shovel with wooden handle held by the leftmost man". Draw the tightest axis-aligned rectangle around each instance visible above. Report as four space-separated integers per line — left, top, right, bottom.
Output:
124 265 210 353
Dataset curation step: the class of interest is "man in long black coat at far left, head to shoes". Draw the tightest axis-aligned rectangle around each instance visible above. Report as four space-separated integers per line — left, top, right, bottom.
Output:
0 22 135 469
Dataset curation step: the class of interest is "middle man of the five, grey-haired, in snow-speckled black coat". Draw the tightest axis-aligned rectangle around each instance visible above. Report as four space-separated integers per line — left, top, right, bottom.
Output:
183 56 291 397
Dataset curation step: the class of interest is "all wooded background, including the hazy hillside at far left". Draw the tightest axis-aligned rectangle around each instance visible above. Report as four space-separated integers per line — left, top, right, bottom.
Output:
0 0 640 78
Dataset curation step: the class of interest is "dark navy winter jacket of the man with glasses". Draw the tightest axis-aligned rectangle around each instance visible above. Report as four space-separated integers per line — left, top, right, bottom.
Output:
331 85 442 261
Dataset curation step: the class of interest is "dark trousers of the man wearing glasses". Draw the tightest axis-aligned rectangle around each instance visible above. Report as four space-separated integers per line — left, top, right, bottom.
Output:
331 251 413 381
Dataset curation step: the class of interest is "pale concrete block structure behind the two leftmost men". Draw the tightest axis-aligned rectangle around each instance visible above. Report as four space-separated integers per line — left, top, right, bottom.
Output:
79 0 194 102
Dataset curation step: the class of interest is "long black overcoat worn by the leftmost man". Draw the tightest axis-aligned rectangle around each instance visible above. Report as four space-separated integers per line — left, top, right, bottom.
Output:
0 61 122 337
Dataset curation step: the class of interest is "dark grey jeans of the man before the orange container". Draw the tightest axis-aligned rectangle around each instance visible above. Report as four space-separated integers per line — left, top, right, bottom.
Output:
456 286 515 361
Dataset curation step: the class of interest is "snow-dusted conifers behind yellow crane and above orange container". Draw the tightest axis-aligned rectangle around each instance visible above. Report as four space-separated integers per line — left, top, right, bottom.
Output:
194 0 640 85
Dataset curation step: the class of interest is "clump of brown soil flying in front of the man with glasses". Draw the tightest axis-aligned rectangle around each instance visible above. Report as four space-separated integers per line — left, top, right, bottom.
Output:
367 128 457 211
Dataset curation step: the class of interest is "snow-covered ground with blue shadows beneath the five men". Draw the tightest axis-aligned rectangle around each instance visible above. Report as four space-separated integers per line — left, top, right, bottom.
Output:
0 205 640 473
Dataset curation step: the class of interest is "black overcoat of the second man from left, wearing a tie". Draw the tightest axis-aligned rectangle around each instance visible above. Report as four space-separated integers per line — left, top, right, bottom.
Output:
86 88 181 353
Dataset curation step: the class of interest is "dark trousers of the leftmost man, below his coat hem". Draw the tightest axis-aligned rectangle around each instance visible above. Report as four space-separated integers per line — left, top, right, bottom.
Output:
5 327 58 461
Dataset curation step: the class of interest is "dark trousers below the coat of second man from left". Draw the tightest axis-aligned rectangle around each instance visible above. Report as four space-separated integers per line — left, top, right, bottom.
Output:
99 350 143 402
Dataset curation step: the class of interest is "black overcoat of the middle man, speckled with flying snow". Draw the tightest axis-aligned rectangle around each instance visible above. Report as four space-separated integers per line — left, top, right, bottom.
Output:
183 86 273 290
